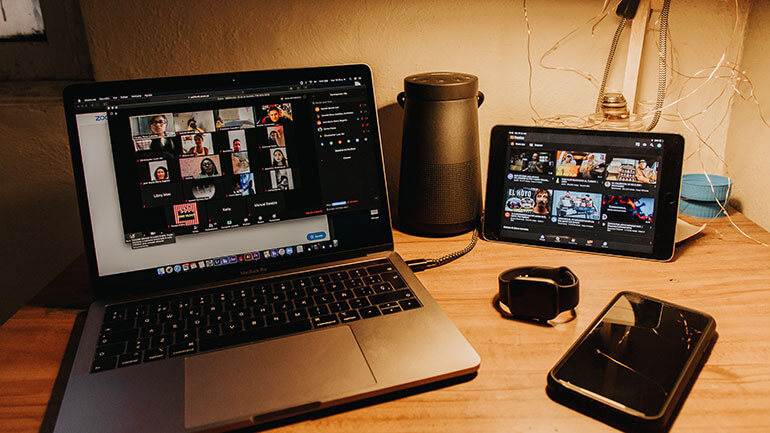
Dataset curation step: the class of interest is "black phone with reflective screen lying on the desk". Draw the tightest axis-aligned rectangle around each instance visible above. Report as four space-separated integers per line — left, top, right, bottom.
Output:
546 292 717 431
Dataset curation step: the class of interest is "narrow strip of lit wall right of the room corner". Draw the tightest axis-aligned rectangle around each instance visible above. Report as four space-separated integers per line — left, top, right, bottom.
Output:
727 2 770 229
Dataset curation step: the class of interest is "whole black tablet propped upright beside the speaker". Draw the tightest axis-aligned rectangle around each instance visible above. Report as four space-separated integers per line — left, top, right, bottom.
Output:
483 125 684 260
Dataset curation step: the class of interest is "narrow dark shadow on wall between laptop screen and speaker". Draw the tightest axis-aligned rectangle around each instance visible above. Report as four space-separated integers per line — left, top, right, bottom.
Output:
377 104 404 227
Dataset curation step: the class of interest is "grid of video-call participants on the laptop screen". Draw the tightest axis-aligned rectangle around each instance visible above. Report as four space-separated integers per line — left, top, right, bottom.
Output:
128 103 299 234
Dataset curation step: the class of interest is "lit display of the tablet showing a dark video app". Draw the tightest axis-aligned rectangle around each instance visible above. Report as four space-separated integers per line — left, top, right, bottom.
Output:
500 130 665 253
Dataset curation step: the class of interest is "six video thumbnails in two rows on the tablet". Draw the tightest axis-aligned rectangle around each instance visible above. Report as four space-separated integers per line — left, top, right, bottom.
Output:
503 146 660 235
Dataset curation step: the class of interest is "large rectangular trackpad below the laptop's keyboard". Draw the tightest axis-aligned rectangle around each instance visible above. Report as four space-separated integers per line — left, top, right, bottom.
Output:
184 326 376 428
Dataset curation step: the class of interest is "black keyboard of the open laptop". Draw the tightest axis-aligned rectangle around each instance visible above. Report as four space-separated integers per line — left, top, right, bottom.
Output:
91 260 422 373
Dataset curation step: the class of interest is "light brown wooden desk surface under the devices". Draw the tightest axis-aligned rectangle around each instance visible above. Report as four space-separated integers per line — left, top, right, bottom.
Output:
0 213 770 433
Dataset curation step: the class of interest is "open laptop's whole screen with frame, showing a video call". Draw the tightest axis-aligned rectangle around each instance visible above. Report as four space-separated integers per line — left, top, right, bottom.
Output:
65 66 391 281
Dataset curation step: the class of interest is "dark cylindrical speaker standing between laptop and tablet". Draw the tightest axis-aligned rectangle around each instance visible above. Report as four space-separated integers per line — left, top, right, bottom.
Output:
398 72 484 236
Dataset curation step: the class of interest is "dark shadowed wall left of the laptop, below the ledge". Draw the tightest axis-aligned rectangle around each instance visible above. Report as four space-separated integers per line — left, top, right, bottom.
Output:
0 100 83 324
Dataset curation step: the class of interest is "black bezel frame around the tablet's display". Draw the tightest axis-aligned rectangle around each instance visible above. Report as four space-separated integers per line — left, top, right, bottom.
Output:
482 125 684 261
